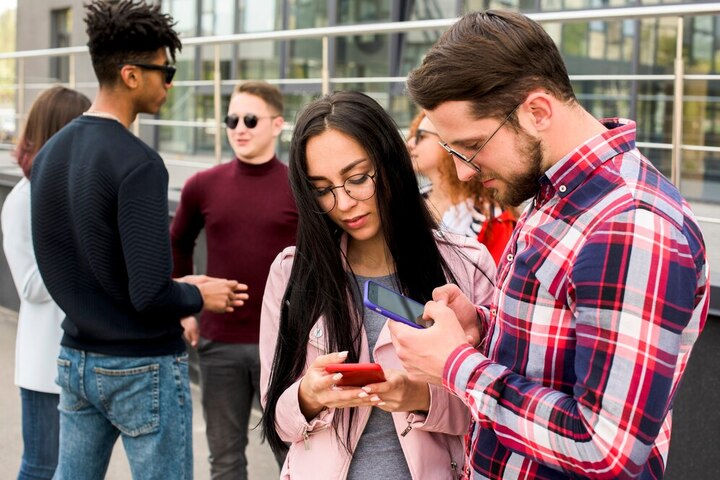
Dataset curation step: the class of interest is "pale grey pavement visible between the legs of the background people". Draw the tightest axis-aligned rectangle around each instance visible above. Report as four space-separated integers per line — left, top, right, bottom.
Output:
0 307 279 480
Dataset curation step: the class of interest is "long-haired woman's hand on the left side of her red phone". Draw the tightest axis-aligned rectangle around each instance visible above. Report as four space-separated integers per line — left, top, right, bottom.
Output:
298 352 386 420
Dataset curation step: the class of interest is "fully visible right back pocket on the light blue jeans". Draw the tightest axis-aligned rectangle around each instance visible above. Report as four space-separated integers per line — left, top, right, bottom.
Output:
93 363 160 437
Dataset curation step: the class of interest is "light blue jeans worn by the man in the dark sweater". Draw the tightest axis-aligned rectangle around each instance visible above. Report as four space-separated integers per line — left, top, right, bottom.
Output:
54 347 193 480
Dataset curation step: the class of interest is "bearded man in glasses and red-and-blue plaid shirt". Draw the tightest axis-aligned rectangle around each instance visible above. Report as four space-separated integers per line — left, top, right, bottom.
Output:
390 11 710 479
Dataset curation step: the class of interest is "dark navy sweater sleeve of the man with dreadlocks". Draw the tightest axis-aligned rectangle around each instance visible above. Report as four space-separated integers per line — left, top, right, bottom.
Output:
118 161 203 317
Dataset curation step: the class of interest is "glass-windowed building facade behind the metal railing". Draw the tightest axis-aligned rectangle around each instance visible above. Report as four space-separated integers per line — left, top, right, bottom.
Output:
9 0 720 203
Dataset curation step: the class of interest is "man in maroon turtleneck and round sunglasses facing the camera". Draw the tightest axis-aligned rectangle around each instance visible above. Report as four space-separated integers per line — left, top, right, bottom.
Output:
171 81 297 480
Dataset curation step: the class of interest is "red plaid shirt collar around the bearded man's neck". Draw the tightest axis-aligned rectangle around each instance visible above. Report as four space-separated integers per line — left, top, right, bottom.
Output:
538 118 636 204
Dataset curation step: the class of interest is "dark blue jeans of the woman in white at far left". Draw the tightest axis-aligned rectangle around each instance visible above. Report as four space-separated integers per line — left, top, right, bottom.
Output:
18 388 60 480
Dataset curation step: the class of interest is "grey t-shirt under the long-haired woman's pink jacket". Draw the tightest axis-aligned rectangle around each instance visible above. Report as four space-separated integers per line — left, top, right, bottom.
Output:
347 275 411 480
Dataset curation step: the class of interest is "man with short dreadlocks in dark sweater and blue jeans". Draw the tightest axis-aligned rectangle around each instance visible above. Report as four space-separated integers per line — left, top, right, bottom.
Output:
31 0 247 480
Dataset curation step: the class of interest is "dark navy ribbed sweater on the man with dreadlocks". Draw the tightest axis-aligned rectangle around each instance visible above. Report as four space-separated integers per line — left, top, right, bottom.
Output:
31 116 202 356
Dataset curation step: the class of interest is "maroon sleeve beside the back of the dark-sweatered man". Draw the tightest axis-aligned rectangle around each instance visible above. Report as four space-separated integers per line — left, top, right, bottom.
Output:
170 175 205 278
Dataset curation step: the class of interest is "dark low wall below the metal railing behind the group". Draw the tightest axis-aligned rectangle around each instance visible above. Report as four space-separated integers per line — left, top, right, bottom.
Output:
0 174 720 480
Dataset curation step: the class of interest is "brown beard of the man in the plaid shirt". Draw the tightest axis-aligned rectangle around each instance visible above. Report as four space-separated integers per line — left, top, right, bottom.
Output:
493 130 544 207
